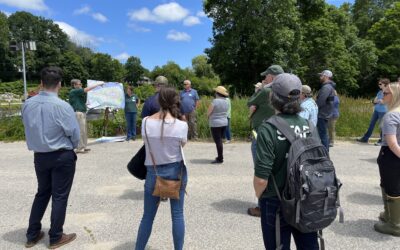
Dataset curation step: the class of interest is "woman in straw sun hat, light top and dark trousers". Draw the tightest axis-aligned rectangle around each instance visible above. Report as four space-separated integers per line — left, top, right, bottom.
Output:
207 86 229 164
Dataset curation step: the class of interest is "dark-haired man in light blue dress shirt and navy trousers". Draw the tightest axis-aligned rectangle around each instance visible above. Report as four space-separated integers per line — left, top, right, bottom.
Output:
22 67 80 249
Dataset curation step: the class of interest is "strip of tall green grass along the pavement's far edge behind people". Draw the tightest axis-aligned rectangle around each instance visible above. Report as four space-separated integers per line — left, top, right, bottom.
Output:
0 96 379 141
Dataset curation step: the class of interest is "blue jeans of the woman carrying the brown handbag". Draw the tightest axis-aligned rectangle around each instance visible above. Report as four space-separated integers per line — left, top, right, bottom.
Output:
135 162 187 250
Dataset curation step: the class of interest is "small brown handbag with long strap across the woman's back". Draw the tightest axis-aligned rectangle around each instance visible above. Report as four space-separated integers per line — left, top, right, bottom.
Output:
144 118 183 200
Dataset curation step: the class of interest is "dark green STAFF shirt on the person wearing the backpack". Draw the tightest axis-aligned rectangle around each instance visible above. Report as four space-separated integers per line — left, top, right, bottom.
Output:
254 114 310 198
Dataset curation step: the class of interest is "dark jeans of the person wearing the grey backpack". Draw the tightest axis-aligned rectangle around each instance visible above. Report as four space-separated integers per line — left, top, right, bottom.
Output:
259 197 319 250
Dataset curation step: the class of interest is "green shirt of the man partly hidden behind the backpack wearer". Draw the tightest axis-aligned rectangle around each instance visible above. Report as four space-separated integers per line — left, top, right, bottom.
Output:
247 88 275 131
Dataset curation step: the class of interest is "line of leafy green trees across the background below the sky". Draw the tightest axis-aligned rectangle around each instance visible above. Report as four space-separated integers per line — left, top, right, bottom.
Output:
0 0 400 96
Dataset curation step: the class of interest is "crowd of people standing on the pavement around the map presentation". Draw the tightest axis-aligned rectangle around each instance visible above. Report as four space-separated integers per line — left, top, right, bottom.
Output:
22 65 400 250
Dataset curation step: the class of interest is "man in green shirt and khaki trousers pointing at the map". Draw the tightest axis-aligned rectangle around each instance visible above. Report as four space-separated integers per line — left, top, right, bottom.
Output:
69 79 104 154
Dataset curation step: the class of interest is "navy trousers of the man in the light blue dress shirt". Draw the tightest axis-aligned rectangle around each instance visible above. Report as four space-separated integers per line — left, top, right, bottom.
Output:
26 150 77 244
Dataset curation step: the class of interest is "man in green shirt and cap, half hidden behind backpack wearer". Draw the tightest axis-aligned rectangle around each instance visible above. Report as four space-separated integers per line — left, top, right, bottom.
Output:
247 65 283 217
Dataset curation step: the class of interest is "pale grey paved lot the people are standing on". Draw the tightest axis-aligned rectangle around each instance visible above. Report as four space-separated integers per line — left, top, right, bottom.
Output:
0 141 400 250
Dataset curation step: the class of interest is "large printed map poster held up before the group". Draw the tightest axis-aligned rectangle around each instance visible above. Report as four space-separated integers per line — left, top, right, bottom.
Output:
86 80 125 109
